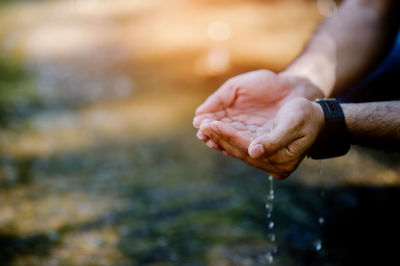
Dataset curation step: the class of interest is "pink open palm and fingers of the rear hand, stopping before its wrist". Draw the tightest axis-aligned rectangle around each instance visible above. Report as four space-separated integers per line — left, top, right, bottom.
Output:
194 70 293 141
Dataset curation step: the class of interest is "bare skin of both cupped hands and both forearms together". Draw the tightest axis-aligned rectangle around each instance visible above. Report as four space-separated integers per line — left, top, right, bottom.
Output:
193 0 399 179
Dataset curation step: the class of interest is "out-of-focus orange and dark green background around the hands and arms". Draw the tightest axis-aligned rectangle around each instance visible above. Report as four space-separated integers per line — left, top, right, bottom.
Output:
0 0 400 265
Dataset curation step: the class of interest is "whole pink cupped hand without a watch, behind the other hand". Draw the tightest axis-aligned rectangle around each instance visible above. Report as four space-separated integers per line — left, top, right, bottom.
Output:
193 70 324 150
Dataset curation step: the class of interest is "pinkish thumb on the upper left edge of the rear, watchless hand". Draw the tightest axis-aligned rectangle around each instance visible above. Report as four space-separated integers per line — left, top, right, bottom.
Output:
196 81 237 115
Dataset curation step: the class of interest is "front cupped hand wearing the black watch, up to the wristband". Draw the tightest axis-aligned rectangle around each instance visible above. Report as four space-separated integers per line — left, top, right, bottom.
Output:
200 98 325 179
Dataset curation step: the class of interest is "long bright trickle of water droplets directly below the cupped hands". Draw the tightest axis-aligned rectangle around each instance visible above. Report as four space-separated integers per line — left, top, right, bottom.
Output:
265 176 278 264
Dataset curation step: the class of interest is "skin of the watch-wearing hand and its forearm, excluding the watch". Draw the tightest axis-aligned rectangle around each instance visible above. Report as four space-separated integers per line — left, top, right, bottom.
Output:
200 98 400 179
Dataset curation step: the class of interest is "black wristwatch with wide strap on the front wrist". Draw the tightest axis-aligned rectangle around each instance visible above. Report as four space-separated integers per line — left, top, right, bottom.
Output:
307 98 350 159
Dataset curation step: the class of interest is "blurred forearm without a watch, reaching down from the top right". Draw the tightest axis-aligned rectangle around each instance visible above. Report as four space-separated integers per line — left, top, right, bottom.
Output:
283 0 396 96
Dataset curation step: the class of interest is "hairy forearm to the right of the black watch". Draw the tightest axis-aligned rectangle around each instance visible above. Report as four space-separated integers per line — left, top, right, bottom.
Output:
341 101 400 150
